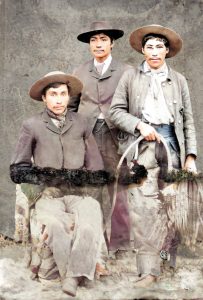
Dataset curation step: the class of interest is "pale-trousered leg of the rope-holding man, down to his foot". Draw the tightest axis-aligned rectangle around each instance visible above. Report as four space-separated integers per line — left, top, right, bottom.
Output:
128 142 167 285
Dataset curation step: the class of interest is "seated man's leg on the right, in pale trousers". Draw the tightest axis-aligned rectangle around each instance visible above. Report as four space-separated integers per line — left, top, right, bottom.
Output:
64 196 103 280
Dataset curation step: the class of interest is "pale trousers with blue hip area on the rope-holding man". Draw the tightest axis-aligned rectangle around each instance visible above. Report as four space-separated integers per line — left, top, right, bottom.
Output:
128 125 180 276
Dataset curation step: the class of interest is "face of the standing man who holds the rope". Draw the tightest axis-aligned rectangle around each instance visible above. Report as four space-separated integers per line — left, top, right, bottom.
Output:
142 38 169 69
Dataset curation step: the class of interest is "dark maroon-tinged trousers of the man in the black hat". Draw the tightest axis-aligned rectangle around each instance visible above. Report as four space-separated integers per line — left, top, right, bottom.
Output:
93 120 130 250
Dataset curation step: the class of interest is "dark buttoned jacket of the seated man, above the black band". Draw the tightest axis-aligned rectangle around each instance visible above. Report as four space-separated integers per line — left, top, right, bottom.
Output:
11 110 103 170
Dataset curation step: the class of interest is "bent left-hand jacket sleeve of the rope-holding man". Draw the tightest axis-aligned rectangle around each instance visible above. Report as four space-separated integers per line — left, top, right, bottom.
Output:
109 69 140 134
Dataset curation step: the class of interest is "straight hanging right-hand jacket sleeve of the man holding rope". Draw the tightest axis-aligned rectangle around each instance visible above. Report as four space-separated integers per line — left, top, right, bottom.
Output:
181 76 197 156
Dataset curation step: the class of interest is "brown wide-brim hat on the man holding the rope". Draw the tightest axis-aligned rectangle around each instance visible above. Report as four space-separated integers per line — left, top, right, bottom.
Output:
129 24 183 58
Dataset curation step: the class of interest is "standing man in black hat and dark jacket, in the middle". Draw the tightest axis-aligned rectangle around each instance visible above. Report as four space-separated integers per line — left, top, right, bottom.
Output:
69 21 130 250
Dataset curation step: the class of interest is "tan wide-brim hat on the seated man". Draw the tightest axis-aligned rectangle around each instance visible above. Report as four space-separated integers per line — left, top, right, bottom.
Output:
29 71 83 101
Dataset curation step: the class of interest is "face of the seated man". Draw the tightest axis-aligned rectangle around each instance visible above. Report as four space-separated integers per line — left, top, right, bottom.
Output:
42 84 70 115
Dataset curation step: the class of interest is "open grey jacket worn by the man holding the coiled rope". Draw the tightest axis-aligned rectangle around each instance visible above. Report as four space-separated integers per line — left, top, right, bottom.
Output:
109 65 197 166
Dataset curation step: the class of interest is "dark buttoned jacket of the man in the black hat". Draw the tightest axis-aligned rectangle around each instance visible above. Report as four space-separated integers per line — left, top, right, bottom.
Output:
68 59 132 129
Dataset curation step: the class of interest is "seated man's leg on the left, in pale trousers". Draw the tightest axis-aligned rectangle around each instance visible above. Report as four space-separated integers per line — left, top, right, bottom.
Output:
35 193 75 278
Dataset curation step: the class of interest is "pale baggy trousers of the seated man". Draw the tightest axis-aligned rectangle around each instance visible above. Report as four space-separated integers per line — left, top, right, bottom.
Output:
35 191 103 280
